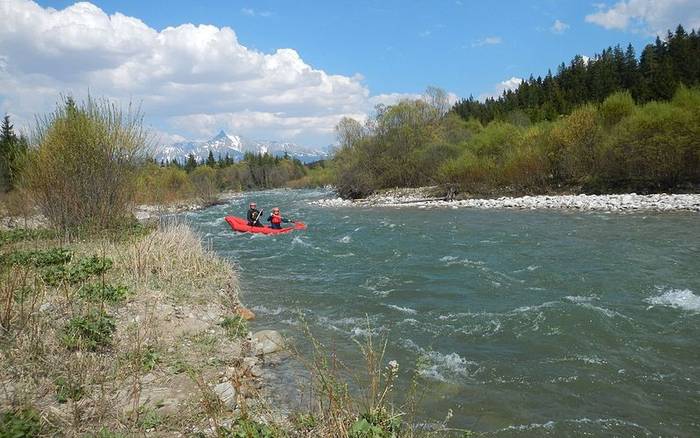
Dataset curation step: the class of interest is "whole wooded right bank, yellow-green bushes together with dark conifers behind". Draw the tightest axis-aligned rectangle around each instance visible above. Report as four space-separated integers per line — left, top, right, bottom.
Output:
332 26 700 198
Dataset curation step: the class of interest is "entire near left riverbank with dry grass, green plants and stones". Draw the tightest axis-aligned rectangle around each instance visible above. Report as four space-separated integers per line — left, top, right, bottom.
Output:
0 224 286 436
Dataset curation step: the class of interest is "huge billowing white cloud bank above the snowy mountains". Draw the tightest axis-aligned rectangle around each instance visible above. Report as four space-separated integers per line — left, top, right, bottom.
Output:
0 0 440 146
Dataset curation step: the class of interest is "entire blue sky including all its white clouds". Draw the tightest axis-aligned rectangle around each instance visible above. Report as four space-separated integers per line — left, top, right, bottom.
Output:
0 0 700 147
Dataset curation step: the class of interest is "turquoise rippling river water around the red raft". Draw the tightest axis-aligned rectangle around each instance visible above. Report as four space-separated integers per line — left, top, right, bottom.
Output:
186 190 700 437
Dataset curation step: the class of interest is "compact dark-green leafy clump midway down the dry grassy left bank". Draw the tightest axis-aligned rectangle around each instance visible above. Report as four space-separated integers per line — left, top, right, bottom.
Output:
61 309 116 351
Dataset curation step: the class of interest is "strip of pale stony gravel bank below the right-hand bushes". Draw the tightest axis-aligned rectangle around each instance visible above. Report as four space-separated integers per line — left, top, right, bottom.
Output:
313 187 700 212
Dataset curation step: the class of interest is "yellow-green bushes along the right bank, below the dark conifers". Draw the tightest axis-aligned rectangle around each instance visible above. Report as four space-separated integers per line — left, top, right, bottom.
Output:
334 81 700 198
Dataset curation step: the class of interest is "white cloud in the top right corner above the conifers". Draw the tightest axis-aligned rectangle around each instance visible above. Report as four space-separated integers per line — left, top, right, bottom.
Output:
586 0 700 36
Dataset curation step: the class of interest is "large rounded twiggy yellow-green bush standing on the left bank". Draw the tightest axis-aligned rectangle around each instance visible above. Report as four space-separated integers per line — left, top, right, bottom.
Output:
27 97 147 229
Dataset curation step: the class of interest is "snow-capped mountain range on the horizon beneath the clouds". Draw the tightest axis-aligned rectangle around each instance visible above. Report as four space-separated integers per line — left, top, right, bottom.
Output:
155 130 328 163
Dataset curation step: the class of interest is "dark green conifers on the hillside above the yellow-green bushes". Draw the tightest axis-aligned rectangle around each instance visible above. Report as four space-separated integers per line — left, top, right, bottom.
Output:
454 25 700 124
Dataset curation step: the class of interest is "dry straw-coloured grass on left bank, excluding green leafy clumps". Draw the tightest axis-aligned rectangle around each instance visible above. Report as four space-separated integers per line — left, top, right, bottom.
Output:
0 224 246 435
